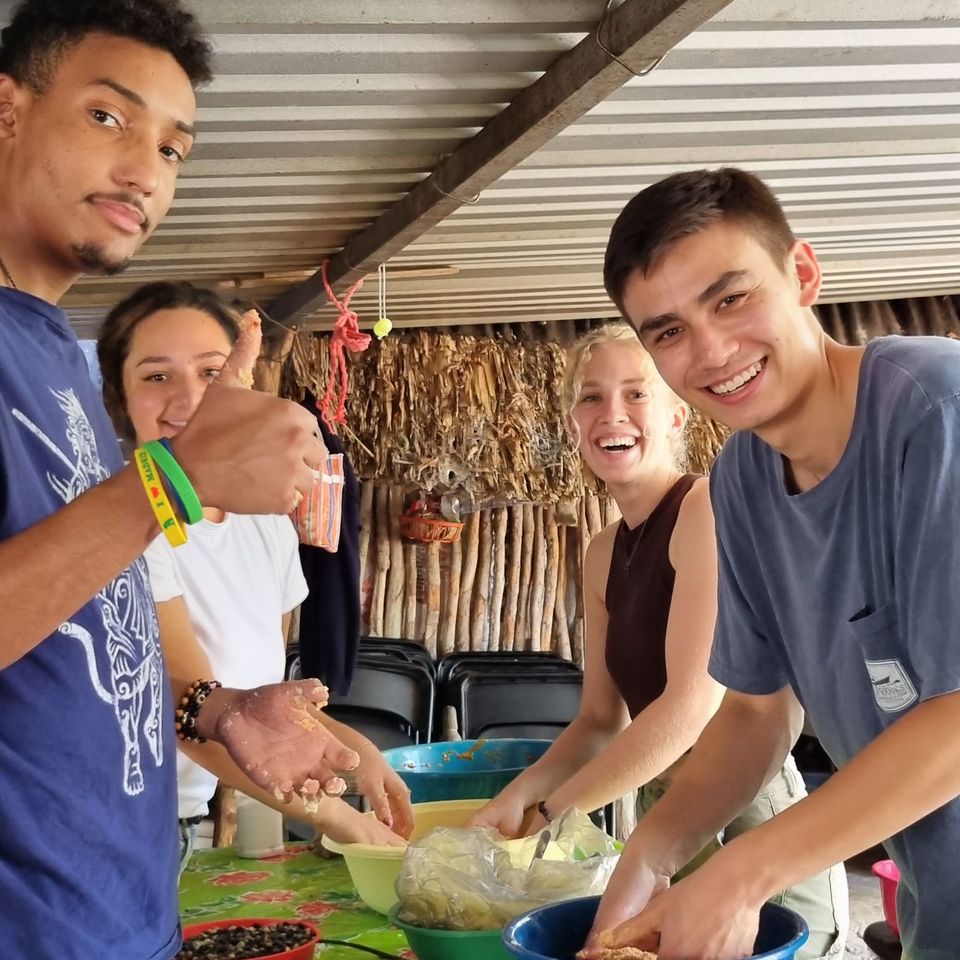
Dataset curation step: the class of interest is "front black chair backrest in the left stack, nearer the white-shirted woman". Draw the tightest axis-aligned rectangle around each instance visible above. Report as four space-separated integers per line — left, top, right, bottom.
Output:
326 653 434 749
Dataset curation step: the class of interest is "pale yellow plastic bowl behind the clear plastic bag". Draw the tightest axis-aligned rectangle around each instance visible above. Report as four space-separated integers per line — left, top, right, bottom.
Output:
321 800 487 913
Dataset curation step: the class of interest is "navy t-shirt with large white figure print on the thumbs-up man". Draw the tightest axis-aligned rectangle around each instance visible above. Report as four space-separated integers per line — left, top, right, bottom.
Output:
0 289 180 960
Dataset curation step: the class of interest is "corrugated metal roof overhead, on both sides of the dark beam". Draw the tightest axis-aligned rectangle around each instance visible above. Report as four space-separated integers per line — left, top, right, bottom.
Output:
15 0 960 334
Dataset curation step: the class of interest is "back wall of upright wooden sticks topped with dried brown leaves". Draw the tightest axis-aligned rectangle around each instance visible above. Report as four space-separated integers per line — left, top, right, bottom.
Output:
282 323 726 663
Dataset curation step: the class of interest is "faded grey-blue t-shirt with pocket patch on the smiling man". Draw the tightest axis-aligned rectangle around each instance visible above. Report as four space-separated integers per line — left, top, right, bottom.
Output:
710 337 960 960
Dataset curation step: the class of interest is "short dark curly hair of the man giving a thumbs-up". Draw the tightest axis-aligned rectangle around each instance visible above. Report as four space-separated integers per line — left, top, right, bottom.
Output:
0 0 213 93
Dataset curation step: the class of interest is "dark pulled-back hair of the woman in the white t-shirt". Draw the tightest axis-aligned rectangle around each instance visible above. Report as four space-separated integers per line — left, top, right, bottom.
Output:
97 280 240 441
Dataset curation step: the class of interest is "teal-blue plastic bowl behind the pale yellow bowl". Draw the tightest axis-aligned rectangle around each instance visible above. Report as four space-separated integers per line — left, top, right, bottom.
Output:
383 740 553 803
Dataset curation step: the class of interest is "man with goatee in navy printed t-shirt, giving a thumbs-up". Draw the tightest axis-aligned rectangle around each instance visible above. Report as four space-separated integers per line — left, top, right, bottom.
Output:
0 0 357 960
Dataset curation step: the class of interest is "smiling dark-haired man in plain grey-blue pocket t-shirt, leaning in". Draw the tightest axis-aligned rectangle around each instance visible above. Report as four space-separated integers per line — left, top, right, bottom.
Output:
591 169 960 960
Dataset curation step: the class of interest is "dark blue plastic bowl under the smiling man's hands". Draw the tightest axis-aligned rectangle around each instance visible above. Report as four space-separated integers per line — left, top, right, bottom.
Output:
503 897 810 960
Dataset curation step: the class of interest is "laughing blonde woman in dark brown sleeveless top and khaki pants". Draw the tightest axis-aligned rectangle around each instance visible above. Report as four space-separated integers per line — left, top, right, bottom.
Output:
473 323 847 958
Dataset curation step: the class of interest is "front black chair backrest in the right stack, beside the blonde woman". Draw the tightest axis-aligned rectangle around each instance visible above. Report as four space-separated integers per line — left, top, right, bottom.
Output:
459 668 583 740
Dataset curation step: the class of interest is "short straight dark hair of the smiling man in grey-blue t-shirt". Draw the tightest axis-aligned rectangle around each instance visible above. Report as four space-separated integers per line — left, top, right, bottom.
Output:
603 167 796 313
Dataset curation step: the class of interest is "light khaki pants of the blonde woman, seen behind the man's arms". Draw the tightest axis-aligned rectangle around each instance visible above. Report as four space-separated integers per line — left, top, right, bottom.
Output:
637 756 850 960
